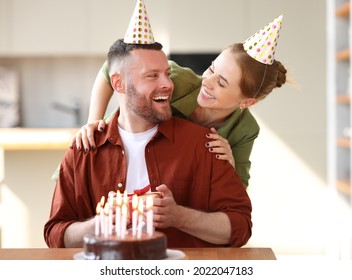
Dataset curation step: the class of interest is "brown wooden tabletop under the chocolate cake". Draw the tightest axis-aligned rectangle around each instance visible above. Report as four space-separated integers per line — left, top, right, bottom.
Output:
0 248 276 260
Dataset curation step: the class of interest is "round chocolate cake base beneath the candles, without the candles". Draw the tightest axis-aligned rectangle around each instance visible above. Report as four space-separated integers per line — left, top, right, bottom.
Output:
83 231 167 260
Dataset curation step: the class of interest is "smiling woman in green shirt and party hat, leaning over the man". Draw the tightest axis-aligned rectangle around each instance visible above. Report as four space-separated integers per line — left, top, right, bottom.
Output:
71 16 287 187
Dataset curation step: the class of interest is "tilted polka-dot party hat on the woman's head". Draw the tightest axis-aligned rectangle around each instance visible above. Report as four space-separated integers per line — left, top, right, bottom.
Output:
243 15 283 65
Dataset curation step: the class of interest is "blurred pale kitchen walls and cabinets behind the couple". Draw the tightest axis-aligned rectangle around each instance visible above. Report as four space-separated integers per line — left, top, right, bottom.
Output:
0 0 352 259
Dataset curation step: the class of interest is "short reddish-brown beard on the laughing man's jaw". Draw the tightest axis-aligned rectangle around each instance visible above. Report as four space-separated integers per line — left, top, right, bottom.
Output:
126 83 172 124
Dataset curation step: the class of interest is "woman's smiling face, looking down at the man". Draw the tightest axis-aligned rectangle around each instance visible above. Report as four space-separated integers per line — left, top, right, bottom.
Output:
197 50 245 111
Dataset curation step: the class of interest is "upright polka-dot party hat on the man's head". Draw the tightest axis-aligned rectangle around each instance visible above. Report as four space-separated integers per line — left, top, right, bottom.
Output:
123 0 155 45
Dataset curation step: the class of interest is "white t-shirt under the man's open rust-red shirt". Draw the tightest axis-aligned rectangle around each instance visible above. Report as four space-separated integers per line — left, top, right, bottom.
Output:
119 125 158 193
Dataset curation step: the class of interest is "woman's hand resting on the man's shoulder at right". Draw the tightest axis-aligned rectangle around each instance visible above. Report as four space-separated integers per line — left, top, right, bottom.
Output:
205 127 236 168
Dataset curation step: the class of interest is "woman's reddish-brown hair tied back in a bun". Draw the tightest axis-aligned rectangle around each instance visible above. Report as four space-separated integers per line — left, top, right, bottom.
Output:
226 43 287 100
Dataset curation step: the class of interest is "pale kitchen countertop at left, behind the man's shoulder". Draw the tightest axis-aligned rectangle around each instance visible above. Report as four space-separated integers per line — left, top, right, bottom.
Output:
0 128 78 151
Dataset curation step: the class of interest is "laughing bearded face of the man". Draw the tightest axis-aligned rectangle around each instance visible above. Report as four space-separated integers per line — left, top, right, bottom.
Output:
125 49 174 123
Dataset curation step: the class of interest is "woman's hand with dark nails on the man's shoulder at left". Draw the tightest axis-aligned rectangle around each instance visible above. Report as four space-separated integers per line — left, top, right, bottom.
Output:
70 120 106 152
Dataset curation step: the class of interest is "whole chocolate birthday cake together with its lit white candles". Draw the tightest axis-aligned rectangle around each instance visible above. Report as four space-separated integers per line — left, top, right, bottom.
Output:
83 186 167 260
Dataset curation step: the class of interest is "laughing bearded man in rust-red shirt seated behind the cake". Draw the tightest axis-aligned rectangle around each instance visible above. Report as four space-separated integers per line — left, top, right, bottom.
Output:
44 40 252 248
